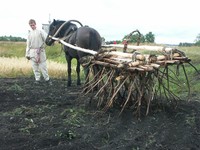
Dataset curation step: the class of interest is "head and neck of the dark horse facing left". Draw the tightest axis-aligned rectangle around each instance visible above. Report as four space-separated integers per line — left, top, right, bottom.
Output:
45 19 83 46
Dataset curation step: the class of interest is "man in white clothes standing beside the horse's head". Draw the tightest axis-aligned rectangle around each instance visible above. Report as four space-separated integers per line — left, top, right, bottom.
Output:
26 19 52 84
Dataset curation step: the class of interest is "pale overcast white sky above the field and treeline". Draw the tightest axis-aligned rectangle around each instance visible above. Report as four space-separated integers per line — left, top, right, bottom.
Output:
0 0 200 44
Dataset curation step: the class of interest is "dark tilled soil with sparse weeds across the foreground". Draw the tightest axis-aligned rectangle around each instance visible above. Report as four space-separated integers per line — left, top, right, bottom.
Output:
0 78 200 150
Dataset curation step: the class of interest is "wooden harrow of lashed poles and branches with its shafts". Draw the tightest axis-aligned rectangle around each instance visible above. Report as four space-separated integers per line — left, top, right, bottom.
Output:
50 38 195 117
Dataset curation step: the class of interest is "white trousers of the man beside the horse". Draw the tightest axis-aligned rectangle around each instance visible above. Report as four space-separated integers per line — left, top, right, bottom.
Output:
30 49 49 81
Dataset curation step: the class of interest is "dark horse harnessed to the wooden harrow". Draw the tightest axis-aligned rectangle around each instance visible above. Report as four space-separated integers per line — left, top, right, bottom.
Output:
46 19 101 86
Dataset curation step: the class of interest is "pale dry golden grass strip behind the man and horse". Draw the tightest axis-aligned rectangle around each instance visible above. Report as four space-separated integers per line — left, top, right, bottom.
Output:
0 57 67 78
